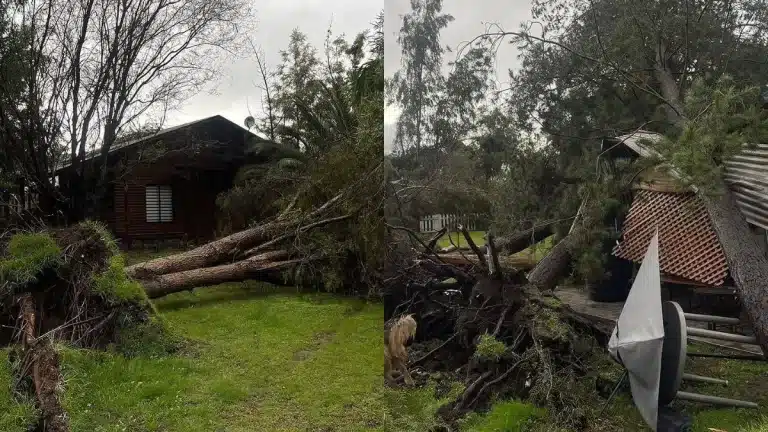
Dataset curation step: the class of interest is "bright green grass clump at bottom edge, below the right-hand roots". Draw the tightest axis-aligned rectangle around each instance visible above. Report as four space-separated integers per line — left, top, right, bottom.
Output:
461 400 547 432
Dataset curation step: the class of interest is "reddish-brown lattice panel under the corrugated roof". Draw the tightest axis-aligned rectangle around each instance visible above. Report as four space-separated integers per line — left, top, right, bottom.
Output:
613 189 728 286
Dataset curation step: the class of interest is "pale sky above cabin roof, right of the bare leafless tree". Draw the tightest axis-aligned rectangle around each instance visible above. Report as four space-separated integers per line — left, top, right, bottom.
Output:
166 0 384 131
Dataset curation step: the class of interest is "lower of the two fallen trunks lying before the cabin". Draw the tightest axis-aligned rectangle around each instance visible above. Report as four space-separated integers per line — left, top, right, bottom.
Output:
139 250 300 298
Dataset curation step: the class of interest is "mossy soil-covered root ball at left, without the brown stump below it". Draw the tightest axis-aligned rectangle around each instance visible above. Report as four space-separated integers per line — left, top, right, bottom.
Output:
0 222 172 350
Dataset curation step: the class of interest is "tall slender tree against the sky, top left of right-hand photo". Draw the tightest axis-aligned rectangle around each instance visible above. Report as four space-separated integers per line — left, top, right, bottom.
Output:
390 0 453 154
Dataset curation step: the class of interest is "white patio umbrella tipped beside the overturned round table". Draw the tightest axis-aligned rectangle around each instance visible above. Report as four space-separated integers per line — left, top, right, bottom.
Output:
608 230 664 431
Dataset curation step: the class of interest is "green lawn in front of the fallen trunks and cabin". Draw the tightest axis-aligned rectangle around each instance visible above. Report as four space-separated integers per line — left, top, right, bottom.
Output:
57 283 383 432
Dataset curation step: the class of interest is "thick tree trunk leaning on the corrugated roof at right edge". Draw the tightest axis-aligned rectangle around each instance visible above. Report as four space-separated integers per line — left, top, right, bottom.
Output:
702 188 768 355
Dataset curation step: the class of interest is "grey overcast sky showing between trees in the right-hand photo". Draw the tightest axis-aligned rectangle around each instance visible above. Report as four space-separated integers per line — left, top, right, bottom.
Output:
384 0 531 153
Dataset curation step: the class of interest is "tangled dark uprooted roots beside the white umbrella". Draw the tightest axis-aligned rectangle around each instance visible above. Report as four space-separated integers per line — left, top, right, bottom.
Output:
384 226 610 430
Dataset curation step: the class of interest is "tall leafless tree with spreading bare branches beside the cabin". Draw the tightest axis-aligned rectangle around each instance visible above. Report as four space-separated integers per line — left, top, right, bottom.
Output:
2 0 249 223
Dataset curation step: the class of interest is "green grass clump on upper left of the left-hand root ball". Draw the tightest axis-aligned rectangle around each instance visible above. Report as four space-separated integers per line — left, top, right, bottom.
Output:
0 233 61 289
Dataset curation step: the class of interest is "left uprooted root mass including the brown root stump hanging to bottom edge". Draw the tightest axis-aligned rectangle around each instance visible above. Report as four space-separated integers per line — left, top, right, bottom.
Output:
0 222 180 432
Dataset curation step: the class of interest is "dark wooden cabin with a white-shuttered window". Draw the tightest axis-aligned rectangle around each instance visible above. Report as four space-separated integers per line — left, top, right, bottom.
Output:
56 115 256 247
